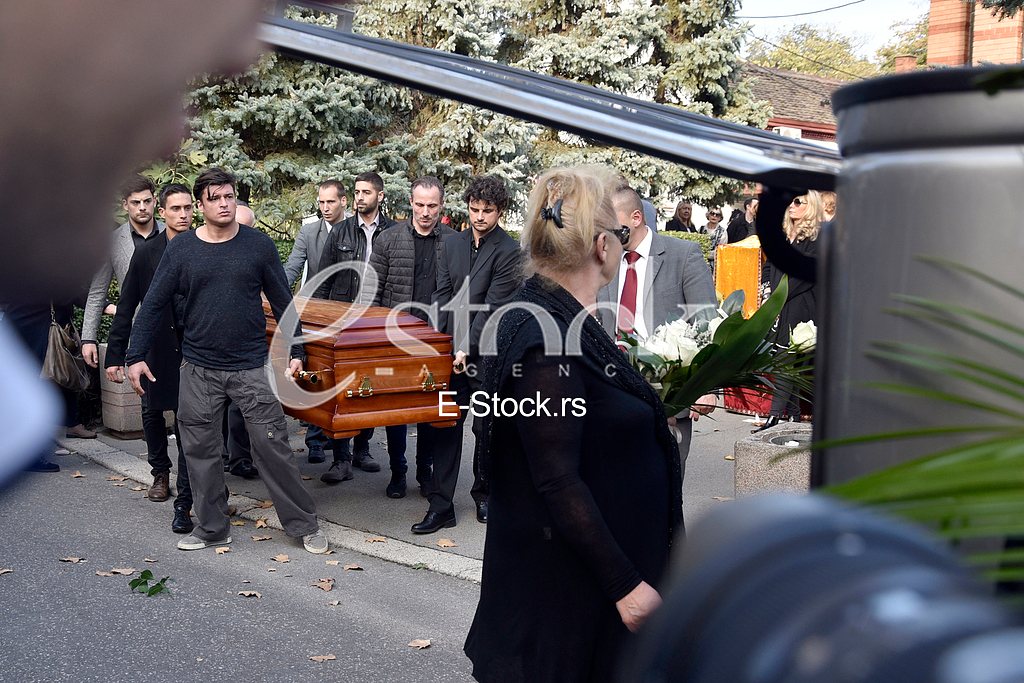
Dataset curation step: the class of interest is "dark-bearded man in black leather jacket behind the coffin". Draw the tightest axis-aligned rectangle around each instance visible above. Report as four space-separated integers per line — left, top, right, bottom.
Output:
309 171 395 483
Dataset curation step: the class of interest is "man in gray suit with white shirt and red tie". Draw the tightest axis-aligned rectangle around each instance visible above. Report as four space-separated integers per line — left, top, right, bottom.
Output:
597 185 718 466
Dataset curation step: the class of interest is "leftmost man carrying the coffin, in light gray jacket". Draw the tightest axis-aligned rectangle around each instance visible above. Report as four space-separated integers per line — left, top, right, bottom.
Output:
82 175 164 368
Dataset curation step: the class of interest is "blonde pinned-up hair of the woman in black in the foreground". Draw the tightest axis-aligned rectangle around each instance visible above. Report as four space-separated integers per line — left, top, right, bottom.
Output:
521 166 620 275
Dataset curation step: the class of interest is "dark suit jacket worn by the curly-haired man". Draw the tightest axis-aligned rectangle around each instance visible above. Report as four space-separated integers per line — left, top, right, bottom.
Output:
431 226 522 357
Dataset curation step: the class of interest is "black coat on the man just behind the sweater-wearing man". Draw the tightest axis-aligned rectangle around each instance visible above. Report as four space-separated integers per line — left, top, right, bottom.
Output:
103 230 181 411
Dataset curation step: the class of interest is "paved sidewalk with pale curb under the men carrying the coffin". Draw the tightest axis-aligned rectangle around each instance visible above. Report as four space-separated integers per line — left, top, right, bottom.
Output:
64 409 751 583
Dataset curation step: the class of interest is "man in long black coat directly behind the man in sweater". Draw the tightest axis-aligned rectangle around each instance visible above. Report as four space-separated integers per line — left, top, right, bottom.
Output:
104 183 193 533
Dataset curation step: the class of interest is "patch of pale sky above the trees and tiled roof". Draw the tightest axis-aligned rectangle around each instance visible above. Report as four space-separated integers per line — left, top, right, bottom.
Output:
737 0 930 57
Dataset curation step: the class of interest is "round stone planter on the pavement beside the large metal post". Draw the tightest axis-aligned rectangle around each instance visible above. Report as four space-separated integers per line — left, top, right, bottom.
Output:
733 422 811 498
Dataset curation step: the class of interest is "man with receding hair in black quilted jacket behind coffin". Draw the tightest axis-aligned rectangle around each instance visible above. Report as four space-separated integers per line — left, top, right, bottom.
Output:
362 176 456 498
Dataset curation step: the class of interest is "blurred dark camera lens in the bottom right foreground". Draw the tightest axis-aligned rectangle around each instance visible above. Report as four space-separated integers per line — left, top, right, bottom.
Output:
620 496 1024 683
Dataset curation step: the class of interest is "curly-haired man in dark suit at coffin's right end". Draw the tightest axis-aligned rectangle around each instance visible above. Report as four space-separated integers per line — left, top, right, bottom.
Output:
412 176 522 533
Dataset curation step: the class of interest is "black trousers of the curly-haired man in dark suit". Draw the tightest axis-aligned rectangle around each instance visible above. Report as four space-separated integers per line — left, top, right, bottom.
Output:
427 373 487 514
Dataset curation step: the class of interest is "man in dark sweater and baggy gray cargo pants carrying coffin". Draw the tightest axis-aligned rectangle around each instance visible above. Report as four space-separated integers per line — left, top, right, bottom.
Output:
125 169 328 553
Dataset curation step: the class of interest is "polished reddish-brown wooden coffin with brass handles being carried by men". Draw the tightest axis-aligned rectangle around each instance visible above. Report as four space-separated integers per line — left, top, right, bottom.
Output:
263 297 459 438
